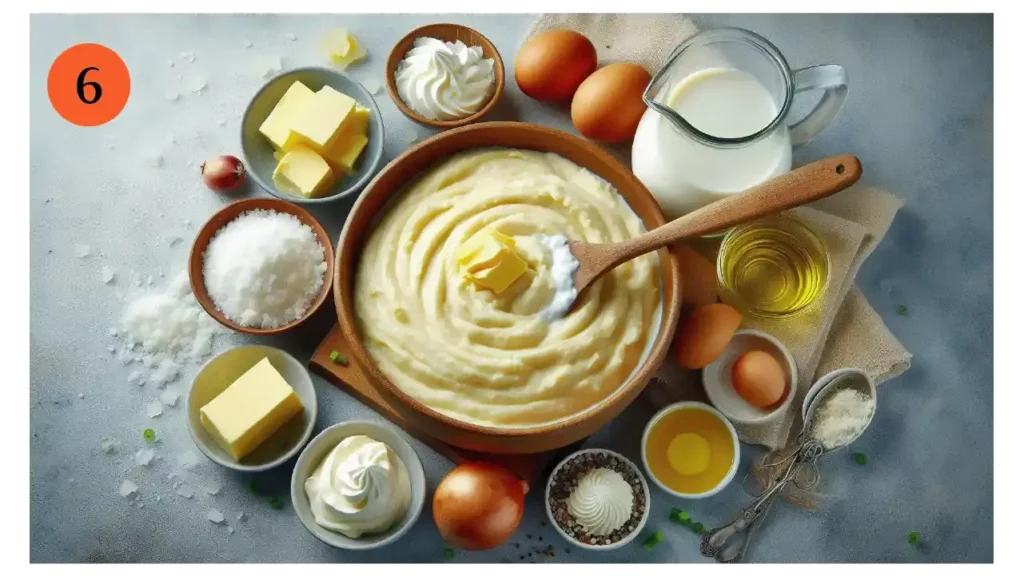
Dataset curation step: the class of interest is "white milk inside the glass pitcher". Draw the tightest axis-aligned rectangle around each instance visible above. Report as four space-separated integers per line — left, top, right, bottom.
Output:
633 68 793 218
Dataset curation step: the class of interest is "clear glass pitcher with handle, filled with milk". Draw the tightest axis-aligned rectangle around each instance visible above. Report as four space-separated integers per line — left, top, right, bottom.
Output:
633 28 847 218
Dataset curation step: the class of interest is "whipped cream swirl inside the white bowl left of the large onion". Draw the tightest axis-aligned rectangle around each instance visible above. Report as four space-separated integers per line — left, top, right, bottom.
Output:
305 436 412 538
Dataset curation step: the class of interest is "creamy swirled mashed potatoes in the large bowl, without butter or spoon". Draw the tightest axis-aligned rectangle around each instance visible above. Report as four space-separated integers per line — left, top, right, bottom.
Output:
354 149 662 427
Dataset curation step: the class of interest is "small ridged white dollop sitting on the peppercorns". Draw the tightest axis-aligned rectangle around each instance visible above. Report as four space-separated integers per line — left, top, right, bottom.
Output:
568 468 633 536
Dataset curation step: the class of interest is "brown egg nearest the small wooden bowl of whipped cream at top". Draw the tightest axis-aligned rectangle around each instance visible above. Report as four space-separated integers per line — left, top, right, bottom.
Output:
515 30 597 101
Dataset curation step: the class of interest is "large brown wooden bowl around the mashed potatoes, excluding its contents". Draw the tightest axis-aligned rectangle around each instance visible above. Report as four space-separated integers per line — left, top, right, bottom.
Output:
334 122 681 454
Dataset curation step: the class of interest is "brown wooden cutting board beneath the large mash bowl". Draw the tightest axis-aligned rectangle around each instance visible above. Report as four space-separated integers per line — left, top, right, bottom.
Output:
309 324 584 487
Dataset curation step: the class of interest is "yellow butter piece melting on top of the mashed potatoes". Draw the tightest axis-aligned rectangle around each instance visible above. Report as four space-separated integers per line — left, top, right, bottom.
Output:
456 230 529 294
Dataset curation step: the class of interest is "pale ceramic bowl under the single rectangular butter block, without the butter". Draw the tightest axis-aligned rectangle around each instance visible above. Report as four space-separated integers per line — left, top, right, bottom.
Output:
187 345 316 472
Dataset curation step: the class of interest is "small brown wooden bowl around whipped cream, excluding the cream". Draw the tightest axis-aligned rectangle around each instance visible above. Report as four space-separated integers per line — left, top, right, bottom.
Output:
384 24 505 130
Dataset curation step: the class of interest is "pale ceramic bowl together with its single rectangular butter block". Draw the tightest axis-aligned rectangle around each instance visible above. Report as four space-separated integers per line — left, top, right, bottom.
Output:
186 345 316 472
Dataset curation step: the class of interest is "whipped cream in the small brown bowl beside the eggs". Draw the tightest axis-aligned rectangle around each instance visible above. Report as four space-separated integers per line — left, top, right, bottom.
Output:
394 38 495 121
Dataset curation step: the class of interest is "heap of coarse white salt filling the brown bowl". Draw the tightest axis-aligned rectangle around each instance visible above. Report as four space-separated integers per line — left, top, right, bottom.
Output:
203 210 327 329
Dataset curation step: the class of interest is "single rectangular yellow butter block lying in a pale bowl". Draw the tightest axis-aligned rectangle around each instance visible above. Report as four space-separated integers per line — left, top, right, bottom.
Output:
200 358 303 461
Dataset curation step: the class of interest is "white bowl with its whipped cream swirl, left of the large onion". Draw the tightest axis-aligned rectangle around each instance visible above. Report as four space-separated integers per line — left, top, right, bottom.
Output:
291 420 427 550
